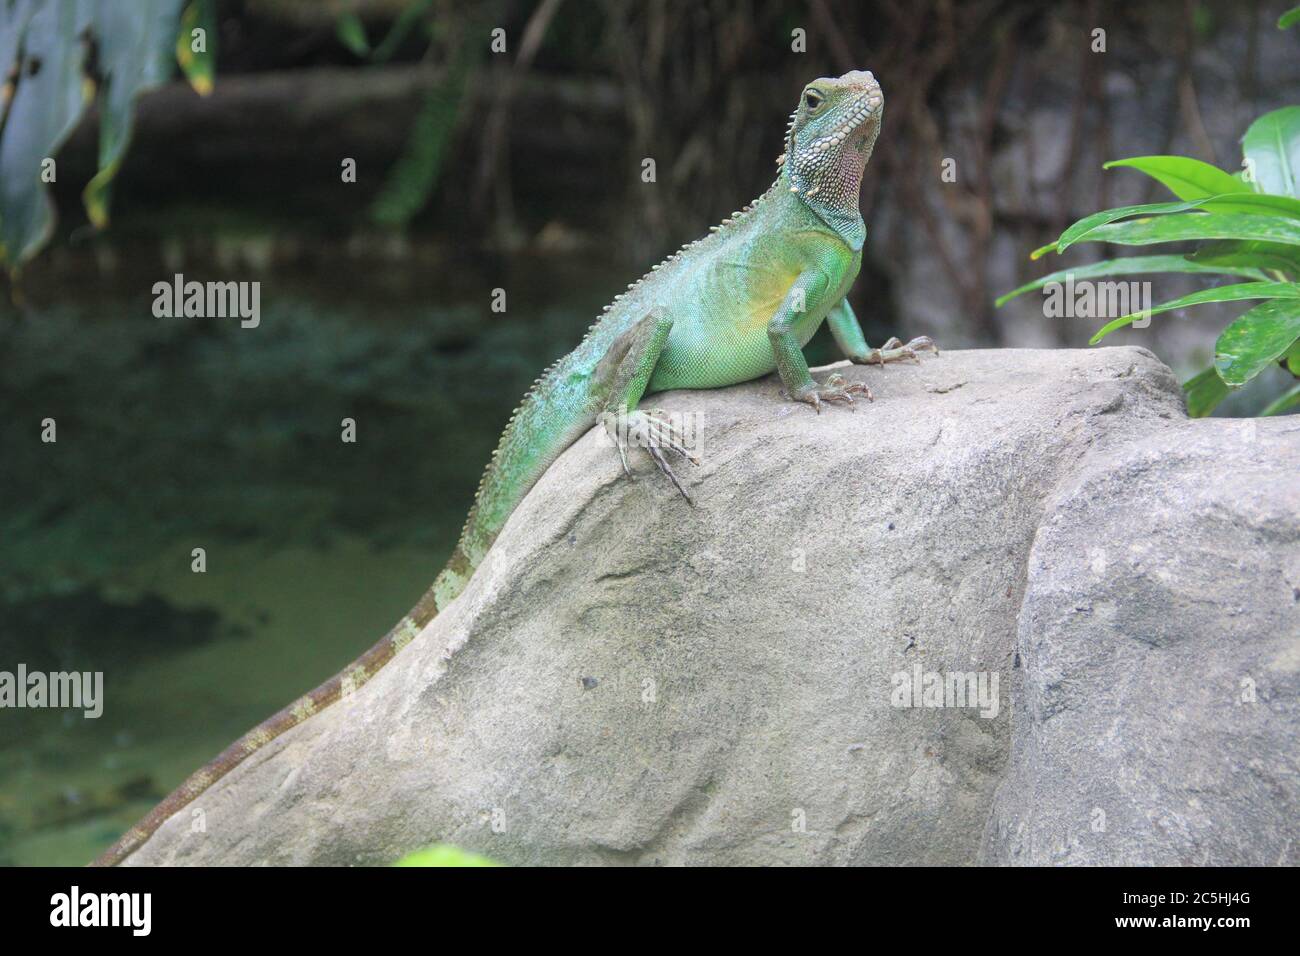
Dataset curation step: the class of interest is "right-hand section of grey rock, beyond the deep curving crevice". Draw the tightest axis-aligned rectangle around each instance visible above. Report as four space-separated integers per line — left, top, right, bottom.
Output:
985 418 1300 865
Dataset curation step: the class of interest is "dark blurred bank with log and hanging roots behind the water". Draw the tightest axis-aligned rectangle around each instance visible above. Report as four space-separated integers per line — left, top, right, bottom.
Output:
10 0 1300 343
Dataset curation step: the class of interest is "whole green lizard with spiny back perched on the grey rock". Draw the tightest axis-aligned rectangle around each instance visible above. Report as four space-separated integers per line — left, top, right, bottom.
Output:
96 70 937 865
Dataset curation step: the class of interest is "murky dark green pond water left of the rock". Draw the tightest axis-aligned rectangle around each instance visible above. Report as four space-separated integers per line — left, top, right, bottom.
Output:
0 248 660 865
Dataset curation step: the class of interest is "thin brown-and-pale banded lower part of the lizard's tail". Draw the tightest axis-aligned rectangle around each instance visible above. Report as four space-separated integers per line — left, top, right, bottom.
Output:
91 574 449 866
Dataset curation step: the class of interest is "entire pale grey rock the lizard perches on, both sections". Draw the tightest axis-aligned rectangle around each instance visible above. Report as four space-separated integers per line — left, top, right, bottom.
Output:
119 349 1300 865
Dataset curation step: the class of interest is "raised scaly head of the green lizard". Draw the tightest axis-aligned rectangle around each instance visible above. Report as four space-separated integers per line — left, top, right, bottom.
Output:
785 70 885 216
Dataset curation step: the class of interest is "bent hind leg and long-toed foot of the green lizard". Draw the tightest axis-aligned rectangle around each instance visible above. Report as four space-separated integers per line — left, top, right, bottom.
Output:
593 308 699 503
